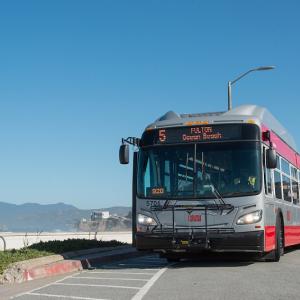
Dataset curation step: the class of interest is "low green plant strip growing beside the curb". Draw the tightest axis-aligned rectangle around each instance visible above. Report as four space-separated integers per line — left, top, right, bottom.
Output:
0 239 127 274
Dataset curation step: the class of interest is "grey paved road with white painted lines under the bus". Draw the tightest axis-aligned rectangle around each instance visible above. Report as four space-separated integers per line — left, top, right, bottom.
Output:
4 246 300 300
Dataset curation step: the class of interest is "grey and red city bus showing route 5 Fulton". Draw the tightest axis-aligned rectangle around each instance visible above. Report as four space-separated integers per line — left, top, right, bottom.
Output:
119 105 300 261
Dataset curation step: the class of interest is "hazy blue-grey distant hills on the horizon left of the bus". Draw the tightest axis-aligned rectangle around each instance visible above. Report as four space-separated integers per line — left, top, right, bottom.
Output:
0 202 131 232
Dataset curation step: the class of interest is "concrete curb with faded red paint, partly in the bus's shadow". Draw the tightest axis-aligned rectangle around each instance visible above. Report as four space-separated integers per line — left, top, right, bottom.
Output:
0 246 146 284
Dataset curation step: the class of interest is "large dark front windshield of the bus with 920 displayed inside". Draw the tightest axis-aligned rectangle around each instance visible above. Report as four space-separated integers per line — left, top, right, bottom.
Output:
137 141 262 199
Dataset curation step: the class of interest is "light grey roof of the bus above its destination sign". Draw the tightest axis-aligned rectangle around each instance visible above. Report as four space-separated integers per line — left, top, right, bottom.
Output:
147 105 298 152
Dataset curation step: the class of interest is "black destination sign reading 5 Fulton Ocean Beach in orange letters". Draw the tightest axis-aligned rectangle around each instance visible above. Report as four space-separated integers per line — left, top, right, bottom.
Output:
141 124 259 146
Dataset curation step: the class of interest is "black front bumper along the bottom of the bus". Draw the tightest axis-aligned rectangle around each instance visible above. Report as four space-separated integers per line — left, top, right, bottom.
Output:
136 230 264 253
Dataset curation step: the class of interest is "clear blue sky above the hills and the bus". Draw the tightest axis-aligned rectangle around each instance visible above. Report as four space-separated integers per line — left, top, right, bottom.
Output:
0 0 300 208
